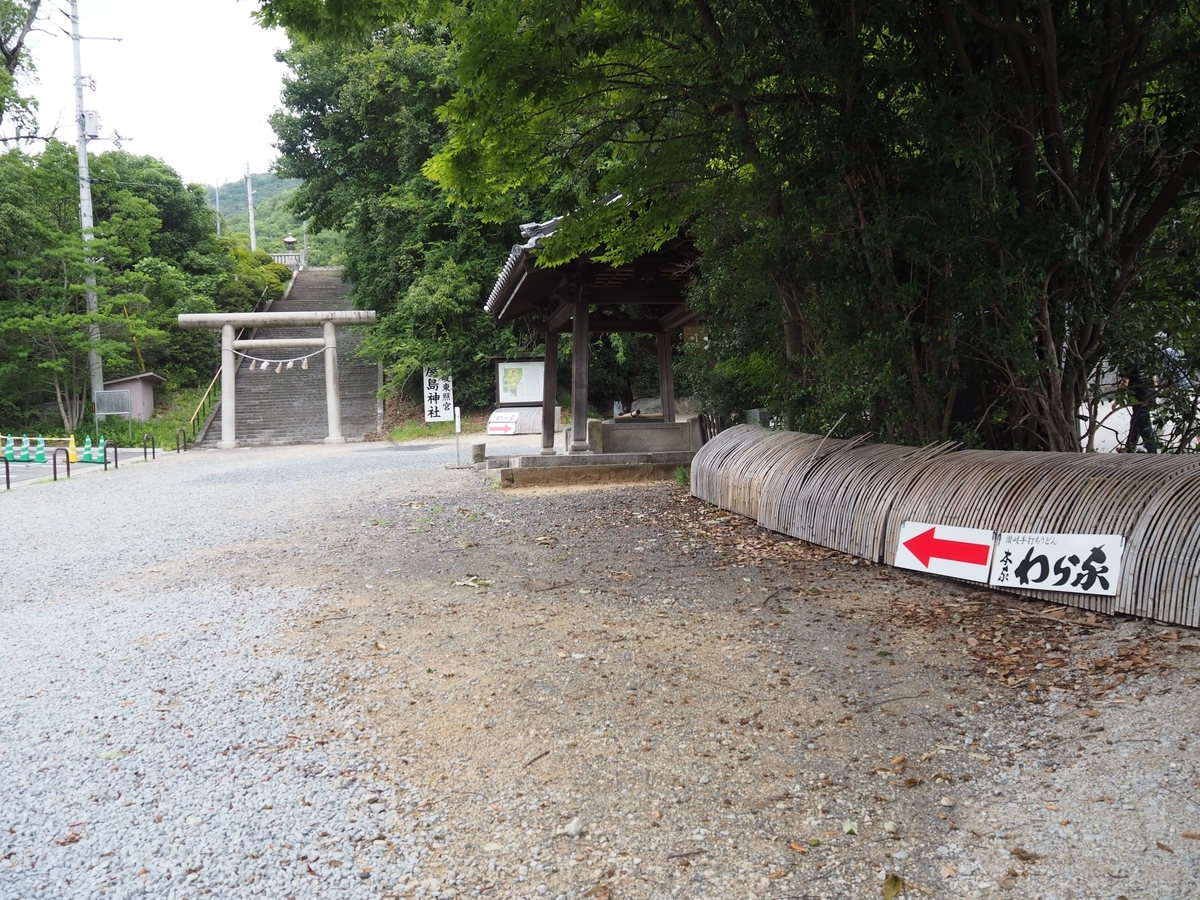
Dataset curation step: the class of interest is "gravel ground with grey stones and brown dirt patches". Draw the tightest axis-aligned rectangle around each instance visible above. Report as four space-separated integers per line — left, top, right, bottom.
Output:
0 438 1200 900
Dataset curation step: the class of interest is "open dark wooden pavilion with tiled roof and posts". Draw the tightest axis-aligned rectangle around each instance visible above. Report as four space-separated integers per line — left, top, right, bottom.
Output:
484 218 700 455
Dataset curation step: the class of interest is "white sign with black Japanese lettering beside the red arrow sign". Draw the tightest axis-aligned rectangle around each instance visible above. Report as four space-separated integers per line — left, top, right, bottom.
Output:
988 534 1124 596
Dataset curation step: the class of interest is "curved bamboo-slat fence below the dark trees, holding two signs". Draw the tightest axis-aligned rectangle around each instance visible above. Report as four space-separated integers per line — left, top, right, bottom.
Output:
691 425 1200 628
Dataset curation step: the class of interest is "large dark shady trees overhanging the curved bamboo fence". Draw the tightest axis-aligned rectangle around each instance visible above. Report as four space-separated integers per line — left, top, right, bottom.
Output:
262 0 1200 449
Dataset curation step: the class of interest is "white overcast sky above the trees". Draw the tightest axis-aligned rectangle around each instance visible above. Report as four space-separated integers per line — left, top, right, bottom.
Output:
24 0 287 185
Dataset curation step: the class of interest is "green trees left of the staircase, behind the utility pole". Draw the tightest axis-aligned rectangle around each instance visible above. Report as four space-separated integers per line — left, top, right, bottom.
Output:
0 140 290 431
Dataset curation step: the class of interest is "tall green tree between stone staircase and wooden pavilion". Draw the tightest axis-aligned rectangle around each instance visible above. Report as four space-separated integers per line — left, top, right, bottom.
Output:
272 28 532 407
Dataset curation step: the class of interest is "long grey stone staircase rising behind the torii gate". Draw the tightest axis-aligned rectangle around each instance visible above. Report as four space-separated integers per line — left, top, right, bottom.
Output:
199 269 378 446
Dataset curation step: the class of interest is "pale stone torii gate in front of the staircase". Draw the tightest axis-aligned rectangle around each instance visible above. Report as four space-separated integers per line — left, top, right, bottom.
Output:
179 310 376 450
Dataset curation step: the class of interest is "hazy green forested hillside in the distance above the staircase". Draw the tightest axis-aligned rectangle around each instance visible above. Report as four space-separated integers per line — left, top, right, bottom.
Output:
208 173 342 265
